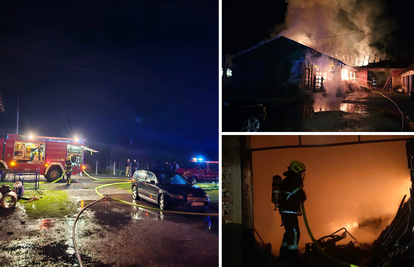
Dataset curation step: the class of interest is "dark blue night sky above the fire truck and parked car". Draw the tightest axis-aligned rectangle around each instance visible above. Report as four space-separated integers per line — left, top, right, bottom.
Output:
0 0 218 161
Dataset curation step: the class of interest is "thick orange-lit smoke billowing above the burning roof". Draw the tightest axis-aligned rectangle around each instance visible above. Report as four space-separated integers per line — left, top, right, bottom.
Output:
270 0 392 66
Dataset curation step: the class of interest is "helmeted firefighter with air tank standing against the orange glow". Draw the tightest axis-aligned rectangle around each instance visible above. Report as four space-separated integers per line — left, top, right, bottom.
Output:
279 161 306 266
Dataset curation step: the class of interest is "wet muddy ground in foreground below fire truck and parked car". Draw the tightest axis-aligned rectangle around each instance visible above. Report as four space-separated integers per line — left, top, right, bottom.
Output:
0 177 218 266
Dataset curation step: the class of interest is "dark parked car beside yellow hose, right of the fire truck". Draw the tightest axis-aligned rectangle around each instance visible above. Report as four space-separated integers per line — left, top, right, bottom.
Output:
131 170 210 213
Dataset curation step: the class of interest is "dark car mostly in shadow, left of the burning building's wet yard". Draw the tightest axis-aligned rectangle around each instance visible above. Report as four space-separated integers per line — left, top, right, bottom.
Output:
222 97 267 132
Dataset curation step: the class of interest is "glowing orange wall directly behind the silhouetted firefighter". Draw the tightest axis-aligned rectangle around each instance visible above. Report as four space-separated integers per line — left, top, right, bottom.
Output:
252 136 411 255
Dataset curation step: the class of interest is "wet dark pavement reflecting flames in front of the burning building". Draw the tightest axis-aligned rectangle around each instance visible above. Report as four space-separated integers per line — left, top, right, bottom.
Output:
264 90 414 132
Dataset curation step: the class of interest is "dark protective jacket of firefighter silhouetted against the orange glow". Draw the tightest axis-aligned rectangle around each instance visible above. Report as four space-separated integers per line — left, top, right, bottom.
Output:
279 170 306 215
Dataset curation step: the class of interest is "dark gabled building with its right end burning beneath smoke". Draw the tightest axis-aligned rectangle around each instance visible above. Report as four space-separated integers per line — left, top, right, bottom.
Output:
232 36 357 97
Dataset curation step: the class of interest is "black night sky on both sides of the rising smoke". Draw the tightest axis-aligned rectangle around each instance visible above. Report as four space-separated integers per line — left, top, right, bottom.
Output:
222 0 414 55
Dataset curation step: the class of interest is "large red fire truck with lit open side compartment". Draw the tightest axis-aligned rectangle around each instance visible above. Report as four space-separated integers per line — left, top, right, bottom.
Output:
0 134 98 182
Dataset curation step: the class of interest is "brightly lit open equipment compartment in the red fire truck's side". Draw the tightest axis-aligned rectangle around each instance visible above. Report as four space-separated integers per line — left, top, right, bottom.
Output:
13 141 45 163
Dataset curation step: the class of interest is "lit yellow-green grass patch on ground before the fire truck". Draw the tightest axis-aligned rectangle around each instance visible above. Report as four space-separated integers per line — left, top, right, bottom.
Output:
19 191 77 219
